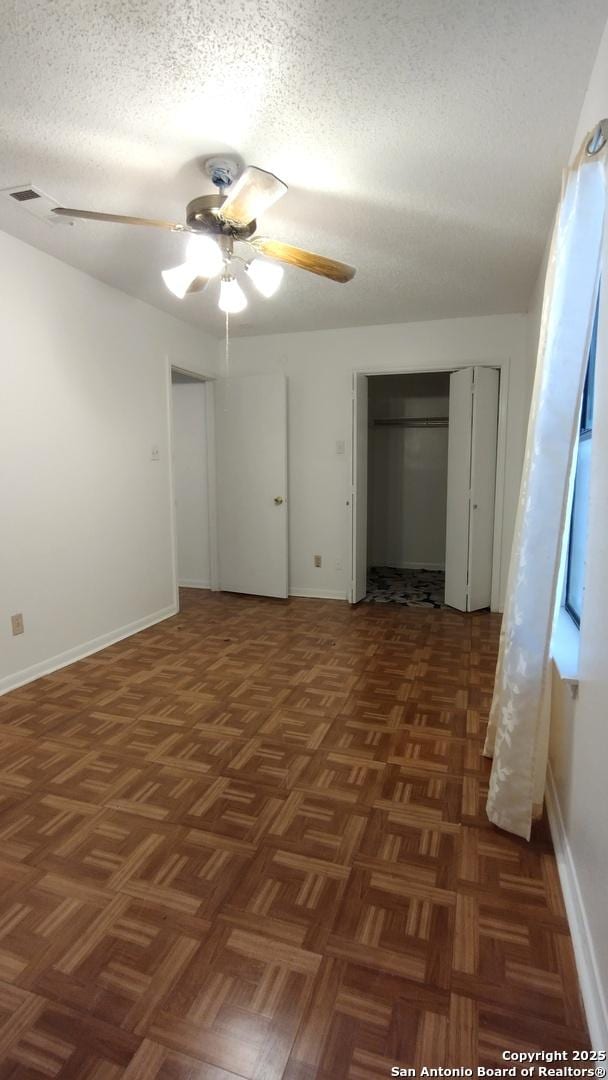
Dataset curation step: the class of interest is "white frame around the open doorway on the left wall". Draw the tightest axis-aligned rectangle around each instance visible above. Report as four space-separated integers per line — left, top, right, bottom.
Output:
165 365 219 611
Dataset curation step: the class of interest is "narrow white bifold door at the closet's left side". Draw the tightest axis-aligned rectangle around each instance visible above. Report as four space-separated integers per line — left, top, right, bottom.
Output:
351 375 368 604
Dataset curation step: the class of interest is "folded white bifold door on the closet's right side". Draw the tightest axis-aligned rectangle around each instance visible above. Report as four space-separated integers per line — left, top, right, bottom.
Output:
445 367 499 611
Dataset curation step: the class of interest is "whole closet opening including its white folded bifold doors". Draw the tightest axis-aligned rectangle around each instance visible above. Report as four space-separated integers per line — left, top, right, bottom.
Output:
351 365 505 611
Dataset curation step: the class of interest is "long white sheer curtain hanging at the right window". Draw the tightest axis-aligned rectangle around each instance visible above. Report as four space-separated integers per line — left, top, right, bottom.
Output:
484 136 606 840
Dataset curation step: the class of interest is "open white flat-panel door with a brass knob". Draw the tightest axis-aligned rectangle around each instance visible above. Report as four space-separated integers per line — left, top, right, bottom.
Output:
214 374 287 597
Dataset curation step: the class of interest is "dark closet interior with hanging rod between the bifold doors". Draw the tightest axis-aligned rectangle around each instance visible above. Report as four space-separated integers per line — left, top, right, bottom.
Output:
364 372 449 608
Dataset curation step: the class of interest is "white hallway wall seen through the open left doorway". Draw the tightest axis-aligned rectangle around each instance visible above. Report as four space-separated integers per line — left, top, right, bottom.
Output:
173 380 211 589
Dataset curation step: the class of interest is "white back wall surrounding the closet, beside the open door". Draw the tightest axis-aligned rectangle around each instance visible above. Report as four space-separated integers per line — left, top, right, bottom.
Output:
228 315 529 613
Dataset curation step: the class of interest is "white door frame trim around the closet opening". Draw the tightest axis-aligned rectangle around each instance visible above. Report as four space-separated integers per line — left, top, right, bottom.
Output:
348 356 511 611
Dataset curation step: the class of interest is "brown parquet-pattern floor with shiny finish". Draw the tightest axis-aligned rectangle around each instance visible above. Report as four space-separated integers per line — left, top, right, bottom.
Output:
0 591 587 1080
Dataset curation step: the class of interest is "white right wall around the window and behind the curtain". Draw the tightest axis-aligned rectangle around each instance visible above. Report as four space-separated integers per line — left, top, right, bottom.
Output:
544 16 608 1049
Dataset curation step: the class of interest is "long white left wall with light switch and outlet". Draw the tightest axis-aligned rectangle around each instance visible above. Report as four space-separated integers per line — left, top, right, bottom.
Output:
0 233 217 689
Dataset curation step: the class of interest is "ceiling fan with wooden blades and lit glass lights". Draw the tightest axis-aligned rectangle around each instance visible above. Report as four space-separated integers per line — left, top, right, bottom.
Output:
54 158 355 314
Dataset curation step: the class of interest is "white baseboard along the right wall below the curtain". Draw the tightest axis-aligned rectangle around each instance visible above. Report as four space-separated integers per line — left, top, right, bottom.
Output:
545 765 608 1050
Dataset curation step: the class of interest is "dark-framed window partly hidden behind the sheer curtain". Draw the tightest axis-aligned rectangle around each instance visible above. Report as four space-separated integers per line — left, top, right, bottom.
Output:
566 302 599 626
